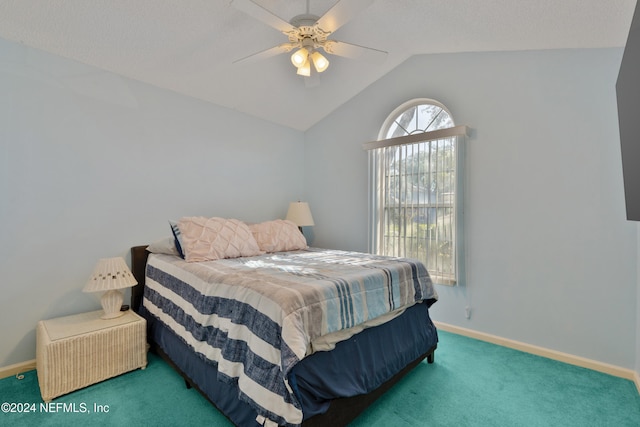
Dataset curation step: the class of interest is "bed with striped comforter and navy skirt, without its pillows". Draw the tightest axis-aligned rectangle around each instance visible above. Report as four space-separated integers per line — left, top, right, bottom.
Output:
131 219 438 427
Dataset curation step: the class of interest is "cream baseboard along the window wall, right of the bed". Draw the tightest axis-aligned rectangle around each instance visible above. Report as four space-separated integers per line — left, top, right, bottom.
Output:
433 322 640 384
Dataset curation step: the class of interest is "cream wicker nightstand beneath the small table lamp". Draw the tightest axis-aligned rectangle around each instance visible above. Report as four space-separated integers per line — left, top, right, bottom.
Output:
36 310 147 402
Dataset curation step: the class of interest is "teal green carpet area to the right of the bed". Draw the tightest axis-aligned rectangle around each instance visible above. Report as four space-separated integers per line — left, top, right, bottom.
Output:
351 331 640 427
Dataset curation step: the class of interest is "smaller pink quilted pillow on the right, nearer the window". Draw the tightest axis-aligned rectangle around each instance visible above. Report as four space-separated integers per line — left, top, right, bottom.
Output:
249 219 308 252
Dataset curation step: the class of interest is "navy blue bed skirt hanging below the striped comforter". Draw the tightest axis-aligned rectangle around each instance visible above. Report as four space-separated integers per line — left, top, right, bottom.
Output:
140 303 438 427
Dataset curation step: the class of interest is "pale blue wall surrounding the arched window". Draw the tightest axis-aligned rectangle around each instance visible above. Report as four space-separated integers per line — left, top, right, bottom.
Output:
305 49 638 369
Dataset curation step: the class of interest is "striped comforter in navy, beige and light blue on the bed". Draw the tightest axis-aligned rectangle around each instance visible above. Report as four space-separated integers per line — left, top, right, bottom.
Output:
144 249 437 425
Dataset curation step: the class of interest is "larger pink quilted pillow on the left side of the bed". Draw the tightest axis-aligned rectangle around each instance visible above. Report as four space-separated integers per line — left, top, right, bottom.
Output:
178 216 264 262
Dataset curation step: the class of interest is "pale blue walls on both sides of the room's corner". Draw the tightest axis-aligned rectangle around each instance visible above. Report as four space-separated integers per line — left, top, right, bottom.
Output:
0 40 640 371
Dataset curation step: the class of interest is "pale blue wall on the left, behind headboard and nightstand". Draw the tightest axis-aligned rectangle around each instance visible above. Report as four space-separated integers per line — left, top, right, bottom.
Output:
0 40 304 366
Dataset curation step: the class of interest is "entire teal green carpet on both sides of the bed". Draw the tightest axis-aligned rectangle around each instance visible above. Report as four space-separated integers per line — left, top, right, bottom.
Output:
0 331 640 427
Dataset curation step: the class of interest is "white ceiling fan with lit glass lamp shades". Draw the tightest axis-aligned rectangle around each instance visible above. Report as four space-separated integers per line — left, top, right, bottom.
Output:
231 0 387 77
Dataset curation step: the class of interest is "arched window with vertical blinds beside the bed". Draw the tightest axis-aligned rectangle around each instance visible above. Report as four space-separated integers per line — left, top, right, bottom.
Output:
364 99 467 285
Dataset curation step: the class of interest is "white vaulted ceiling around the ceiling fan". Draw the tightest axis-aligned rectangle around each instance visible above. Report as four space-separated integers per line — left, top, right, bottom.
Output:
0 0 636 130
